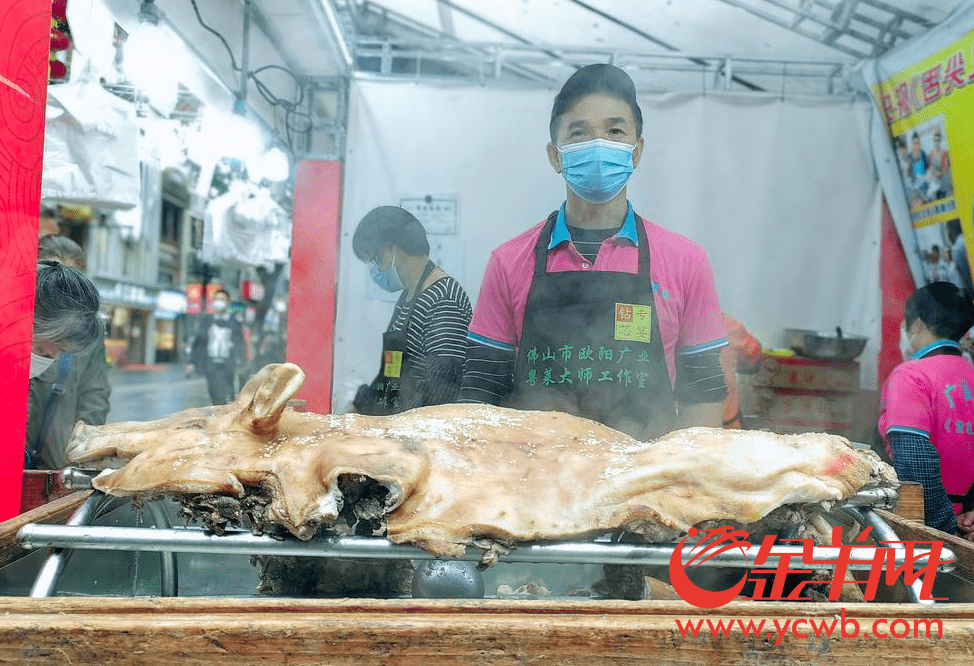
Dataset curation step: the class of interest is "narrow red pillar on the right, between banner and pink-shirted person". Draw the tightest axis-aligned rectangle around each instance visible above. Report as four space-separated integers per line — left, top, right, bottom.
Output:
878 197 916 389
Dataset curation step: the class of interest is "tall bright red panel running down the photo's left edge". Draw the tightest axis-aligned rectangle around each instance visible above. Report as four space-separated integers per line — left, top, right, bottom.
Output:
0 0 51 520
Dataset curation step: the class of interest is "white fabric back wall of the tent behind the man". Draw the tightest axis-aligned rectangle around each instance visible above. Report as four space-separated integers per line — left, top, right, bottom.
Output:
333 80 880 410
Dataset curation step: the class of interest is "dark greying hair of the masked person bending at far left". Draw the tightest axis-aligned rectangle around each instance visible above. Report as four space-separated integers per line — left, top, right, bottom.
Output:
33 261 103 353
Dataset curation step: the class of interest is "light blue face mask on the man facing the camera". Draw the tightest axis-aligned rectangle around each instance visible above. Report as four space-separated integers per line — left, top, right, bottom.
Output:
558 139 636 203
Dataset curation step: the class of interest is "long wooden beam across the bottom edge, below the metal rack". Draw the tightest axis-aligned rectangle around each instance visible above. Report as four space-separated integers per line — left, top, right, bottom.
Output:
0 598 974 666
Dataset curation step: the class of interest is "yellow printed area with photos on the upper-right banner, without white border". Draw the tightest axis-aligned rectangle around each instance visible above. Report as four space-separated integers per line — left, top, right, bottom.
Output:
873 30 974 290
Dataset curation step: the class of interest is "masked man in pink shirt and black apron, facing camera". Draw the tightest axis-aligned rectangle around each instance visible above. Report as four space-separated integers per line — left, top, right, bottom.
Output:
459 64 727 440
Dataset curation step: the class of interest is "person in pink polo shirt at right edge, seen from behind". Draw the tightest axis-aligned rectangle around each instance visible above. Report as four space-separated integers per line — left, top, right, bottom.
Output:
879 282 974 540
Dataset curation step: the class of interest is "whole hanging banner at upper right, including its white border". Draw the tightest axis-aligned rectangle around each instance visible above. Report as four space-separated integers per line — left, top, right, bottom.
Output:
863 2 974 298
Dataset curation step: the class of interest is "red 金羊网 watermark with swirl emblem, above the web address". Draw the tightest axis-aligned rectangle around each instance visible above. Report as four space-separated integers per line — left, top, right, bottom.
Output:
669 525 953 608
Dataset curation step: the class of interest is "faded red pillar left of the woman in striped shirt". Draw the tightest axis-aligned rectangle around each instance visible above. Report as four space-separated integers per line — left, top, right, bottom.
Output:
287 160 343 414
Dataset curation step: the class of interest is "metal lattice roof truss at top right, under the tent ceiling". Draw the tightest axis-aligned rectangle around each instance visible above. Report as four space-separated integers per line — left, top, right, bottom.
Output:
721 0 934 58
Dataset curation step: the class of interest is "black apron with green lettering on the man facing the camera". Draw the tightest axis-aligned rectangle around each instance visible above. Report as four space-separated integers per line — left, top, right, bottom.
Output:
509 212 676 441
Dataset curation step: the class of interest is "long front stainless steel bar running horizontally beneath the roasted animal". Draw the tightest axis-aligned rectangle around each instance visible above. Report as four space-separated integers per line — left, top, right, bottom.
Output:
17 524 953 572
